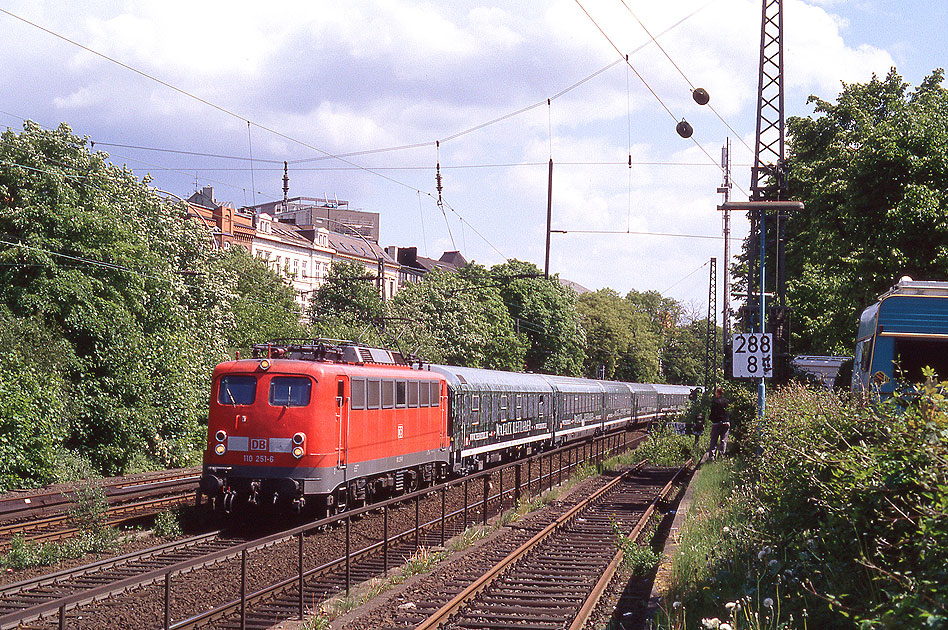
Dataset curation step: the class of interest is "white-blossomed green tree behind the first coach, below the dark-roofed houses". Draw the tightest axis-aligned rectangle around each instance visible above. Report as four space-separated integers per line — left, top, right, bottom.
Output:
391 263 528 371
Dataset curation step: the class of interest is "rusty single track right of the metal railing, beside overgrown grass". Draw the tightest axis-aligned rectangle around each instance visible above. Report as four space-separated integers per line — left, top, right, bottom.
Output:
366 465 683 630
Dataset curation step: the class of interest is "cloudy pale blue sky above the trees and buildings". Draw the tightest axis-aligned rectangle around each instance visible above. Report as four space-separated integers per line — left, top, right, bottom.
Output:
0 0 936 314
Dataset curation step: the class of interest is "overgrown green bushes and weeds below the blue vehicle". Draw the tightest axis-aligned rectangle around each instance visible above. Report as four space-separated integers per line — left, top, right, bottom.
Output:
660 378 948 629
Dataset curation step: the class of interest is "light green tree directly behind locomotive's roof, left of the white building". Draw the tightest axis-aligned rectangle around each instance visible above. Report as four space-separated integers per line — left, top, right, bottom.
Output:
216 246 310 349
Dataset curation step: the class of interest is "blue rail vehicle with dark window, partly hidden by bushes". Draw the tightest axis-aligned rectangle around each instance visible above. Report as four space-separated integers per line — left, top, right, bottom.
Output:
852 278 948 397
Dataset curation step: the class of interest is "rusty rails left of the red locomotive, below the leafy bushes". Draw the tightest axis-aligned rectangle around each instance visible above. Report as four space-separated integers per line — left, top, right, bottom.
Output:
0 468 201 549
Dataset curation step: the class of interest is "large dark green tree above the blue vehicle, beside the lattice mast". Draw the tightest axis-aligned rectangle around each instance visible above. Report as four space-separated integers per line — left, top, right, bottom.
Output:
787 69 948 354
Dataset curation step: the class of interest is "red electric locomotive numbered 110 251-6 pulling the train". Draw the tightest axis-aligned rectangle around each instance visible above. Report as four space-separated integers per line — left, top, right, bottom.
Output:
200 341 450 513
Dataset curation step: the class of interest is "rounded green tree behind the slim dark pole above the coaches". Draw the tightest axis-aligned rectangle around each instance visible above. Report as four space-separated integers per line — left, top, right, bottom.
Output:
491 260 586 376
